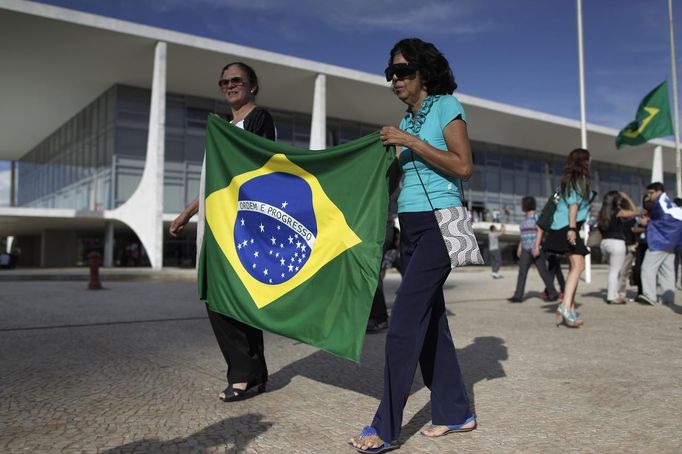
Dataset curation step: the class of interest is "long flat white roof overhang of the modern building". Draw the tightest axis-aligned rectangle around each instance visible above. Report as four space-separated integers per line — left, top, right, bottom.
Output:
0 0 675 169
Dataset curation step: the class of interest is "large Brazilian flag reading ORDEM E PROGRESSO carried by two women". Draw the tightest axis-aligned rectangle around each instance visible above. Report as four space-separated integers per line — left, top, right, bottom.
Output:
198 116 395 362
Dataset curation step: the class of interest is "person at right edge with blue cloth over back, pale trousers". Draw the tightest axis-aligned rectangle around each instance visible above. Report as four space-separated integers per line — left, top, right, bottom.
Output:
640 182 682 306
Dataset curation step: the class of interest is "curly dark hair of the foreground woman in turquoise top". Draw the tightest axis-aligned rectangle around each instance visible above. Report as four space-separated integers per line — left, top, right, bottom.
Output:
388 38 457 95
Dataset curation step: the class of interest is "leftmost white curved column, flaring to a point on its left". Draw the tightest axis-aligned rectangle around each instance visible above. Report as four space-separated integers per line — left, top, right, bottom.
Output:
105 42 167 270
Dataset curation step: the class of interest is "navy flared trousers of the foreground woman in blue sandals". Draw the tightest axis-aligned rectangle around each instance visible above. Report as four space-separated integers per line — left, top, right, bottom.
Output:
372 211 472 442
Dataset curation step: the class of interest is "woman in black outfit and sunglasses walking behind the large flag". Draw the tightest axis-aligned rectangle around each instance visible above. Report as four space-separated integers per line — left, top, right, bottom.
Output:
169 62 276 402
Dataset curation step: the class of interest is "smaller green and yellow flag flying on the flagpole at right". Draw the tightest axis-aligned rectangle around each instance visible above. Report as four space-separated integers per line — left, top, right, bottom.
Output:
616 82 673 149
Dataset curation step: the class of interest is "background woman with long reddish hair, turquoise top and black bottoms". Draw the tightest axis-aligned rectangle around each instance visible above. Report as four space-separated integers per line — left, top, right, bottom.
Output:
535 148 592 328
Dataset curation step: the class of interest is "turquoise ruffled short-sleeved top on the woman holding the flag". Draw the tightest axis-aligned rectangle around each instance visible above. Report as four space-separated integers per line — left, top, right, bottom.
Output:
398 95 466 213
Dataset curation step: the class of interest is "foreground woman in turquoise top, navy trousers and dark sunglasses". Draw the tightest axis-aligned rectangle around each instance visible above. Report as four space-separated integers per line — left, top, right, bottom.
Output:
351 38 476 453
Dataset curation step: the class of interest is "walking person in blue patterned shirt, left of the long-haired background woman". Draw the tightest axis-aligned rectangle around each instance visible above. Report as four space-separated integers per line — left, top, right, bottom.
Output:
507 196 559 303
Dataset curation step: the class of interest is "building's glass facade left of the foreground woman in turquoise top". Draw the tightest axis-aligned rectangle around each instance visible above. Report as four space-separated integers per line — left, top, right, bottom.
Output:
17 85 386 213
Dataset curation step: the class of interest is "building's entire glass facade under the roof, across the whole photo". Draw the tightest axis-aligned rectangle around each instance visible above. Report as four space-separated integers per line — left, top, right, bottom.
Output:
17 85 675 265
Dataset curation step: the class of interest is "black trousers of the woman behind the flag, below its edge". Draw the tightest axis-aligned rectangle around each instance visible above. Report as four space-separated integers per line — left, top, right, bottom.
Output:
206 305 268 385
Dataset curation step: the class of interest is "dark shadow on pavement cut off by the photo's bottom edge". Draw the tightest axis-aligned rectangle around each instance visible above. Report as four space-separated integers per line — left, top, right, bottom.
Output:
99 414 273 454
